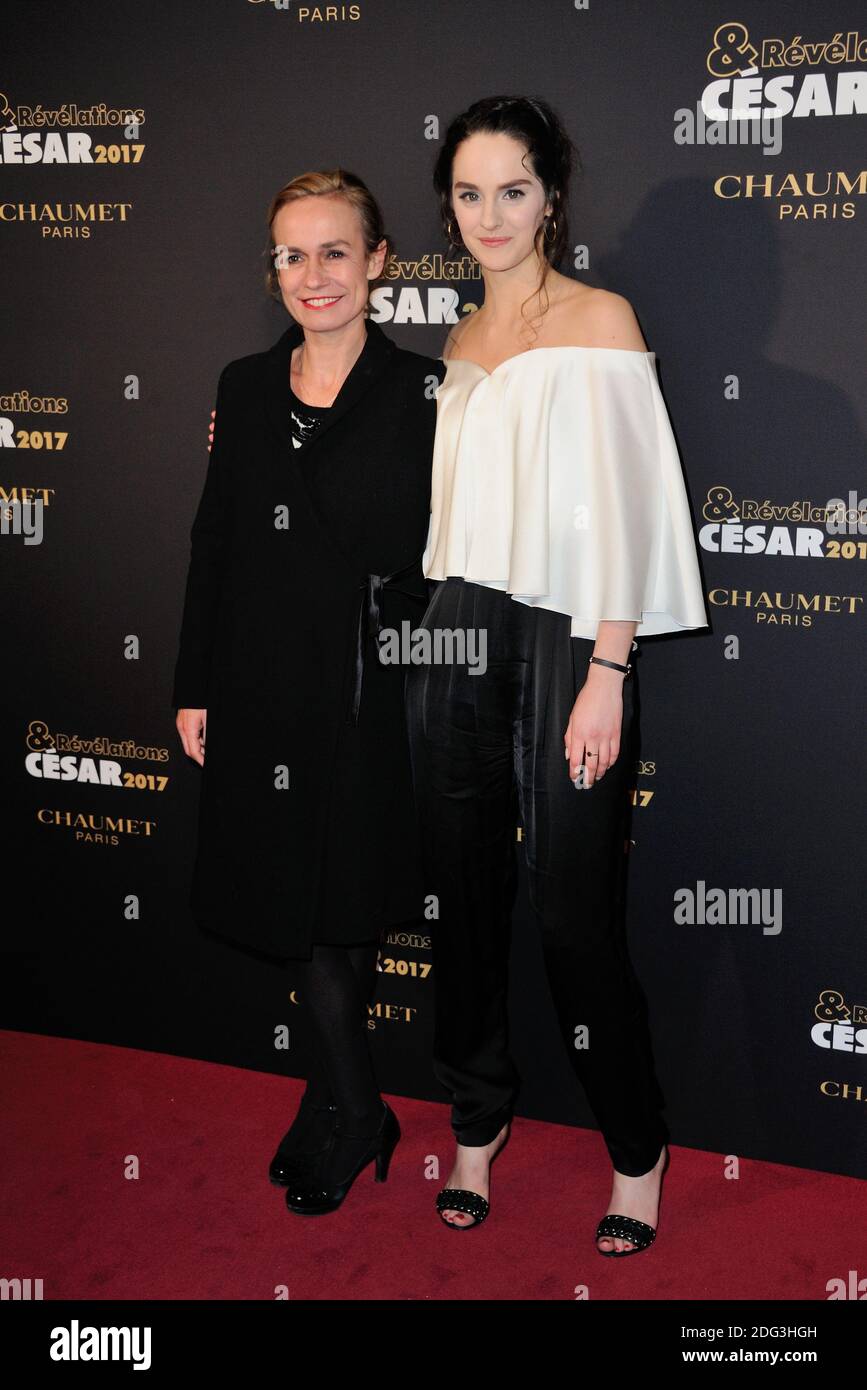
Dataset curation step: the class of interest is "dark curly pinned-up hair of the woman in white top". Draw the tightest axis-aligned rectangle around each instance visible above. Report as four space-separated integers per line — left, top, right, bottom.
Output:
434 96 581 285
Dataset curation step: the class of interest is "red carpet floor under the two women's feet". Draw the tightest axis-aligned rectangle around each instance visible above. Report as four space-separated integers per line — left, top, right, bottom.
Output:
0 1033 867 1301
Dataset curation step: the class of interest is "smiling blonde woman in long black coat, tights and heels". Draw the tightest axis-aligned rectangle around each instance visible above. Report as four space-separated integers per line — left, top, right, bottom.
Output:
172 170 445 1213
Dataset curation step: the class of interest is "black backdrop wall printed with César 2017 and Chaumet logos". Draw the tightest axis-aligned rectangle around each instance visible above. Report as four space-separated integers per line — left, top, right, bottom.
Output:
0 0 867 1176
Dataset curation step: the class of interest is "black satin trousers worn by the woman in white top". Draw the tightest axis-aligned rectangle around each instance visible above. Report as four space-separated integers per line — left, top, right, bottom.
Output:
406 577 668 1177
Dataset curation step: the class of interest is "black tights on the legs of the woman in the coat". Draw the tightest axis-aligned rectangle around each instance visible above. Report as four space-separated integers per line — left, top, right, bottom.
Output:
302 940 382 1134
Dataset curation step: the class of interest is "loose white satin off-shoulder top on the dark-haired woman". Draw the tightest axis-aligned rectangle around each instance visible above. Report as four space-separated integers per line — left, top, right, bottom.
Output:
422 346 709 639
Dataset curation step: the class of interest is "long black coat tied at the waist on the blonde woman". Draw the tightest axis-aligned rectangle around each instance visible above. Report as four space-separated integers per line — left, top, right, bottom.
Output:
172 318 445 959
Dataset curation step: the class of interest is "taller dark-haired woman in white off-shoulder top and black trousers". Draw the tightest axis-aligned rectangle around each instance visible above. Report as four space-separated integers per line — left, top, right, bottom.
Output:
407 97 707 1255
